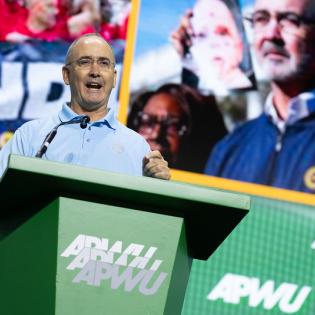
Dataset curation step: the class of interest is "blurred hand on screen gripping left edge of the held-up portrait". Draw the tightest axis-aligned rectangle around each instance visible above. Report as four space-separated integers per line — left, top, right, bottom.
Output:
171 9 194 58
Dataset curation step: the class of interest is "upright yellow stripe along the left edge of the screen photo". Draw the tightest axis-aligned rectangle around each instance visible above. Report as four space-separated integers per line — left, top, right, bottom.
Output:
118 0 140 124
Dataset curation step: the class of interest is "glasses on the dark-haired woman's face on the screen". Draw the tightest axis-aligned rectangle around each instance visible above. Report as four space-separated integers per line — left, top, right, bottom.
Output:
138 112 187 136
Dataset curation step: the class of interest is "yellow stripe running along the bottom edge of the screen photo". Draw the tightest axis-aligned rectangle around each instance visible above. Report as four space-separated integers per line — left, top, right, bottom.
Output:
171 170 315 206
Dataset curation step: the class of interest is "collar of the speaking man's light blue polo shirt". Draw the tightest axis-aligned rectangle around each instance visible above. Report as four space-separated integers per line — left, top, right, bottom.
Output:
59 103 118 130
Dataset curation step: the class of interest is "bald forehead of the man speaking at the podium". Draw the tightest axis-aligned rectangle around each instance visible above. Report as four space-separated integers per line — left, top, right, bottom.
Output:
71 37 114 61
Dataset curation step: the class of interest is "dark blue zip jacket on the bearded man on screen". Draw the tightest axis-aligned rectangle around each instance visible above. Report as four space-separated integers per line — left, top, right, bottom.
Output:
205 111 315 192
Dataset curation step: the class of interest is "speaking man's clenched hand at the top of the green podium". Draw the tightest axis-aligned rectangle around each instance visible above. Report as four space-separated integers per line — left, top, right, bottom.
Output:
143 151 171 180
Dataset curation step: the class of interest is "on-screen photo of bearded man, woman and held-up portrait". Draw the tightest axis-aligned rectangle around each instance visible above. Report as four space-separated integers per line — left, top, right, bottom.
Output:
127 0 315 193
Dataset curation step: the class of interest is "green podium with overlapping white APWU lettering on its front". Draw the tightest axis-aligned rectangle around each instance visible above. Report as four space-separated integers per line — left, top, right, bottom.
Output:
0 155 250 315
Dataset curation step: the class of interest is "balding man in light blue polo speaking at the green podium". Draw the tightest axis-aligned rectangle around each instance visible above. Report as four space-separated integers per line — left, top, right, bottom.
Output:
0 34 170 179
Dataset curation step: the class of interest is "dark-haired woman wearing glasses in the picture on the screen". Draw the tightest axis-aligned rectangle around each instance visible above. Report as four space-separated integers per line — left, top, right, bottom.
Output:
127 84 226 172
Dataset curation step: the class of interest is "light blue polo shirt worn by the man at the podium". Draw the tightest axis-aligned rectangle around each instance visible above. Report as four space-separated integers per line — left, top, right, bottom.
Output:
0 104 150 175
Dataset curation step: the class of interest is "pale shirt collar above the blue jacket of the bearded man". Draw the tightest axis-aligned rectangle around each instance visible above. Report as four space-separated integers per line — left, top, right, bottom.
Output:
265 90 315 130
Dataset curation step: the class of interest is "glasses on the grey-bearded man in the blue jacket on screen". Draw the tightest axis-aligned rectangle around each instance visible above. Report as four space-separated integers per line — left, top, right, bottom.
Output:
245 10 315 34
